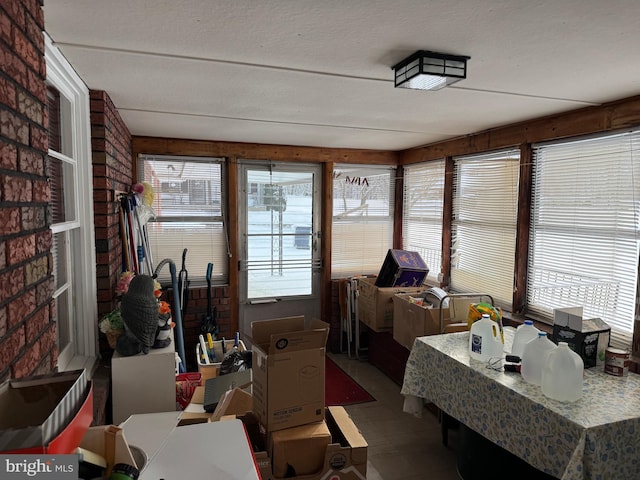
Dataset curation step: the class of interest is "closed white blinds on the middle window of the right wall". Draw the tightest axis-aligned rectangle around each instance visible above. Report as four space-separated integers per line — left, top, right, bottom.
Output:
450 150 520 308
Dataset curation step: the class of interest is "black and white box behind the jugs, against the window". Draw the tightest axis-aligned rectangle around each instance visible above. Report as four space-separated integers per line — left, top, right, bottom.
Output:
553 307 611 368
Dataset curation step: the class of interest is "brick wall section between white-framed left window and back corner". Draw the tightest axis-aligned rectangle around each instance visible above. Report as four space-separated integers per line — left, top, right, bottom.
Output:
90 90 133 356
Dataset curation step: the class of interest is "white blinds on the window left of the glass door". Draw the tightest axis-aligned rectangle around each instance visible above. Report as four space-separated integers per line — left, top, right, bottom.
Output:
138 155 229 284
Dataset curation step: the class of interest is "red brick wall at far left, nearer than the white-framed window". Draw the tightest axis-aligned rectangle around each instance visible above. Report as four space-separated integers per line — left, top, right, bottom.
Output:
0 0 57 380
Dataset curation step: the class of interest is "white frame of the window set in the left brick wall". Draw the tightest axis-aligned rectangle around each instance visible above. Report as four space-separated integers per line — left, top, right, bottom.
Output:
44 33 98 375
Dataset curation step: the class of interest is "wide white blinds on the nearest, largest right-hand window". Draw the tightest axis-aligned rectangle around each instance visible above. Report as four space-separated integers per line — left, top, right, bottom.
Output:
527 132 640 347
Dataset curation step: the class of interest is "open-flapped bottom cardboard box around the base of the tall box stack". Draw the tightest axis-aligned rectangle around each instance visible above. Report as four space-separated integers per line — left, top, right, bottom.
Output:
238 407 368 480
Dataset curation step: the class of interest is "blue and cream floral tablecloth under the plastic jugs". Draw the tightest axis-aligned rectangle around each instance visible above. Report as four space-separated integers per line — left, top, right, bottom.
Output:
402 328 640 480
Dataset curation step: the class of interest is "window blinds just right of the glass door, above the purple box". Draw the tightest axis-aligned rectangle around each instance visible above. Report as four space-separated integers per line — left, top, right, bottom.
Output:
331 165 396 278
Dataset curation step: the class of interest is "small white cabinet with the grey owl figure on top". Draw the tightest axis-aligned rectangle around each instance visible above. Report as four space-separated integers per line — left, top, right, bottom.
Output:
111 337 176 425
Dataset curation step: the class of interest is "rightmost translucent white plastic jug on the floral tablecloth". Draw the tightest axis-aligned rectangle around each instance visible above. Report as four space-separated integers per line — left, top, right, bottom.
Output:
541 342 584 402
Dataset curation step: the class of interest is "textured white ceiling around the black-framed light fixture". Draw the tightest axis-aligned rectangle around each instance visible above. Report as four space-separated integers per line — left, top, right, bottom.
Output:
44 0 640 150
